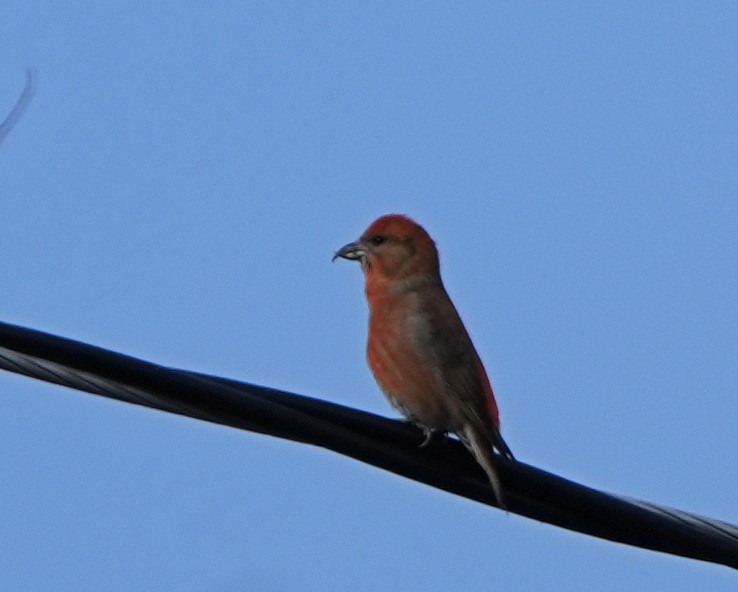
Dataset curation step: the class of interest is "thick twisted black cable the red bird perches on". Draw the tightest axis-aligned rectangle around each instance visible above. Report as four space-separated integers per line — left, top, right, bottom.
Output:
0 323 738 569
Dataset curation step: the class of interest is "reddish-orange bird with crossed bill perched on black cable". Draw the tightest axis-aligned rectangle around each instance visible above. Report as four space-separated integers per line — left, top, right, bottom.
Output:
333 214 515 509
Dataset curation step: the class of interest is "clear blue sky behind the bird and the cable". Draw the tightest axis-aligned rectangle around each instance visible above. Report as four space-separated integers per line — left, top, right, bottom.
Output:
0 0 738 592
